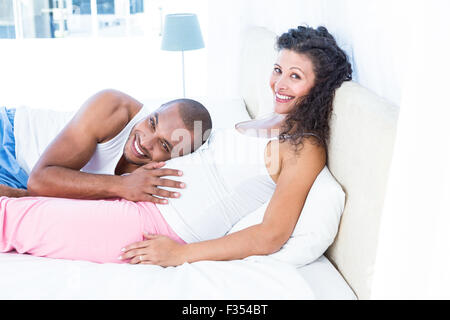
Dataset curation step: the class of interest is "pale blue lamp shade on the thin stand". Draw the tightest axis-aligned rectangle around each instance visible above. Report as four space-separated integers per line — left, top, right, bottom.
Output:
161 13 205 51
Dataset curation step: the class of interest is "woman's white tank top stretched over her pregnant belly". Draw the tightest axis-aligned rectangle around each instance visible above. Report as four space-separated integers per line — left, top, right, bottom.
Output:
157 129 276 243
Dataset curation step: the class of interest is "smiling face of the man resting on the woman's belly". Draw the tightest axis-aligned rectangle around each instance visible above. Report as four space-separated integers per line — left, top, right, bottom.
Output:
123 104 193 165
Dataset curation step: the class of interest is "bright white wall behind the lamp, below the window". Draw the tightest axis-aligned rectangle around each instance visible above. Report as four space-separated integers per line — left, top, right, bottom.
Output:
0 0 208 110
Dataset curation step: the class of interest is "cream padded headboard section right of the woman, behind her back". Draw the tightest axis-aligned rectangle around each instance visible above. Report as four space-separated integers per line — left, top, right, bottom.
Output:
327 81 399 299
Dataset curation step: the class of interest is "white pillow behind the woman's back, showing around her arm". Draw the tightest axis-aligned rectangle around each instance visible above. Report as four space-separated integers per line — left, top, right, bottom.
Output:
228 167 345 267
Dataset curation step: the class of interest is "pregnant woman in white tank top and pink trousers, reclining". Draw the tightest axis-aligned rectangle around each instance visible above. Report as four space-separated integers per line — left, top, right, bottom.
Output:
0 27 351 266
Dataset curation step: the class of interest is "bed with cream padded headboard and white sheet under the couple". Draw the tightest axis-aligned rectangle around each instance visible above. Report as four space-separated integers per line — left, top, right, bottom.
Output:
0 28 397 300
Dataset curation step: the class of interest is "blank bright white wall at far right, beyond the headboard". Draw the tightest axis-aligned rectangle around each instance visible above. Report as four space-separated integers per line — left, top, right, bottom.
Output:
373 0 450 299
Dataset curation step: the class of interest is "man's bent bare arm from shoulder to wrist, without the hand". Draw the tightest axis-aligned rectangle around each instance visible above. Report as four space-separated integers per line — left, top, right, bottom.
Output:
27 90 129 199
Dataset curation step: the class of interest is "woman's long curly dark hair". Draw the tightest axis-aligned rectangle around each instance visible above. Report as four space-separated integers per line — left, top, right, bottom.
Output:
276 26 352 154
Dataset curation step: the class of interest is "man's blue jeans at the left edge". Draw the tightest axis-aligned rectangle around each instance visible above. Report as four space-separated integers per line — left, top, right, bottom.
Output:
0 107 28 189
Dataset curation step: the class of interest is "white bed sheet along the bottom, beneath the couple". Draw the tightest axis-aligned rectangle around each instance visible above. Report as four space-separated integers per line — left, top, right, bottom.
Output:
0 253 354 300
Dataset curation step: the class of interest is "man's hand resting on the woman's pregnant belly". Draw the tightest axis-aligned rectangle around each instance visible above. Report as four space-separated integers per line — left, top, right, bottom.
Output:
120 162 185 204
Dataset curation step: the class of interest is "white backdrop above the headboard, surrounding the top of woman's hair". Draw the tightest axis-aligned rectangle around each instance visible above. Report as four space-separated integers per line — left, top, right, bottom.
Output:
208 0 417 105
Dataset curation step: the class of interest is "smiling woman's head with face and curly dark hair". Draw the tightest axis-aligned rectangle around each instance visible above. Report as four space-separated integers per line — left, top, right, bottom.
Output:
270 26 352 146
